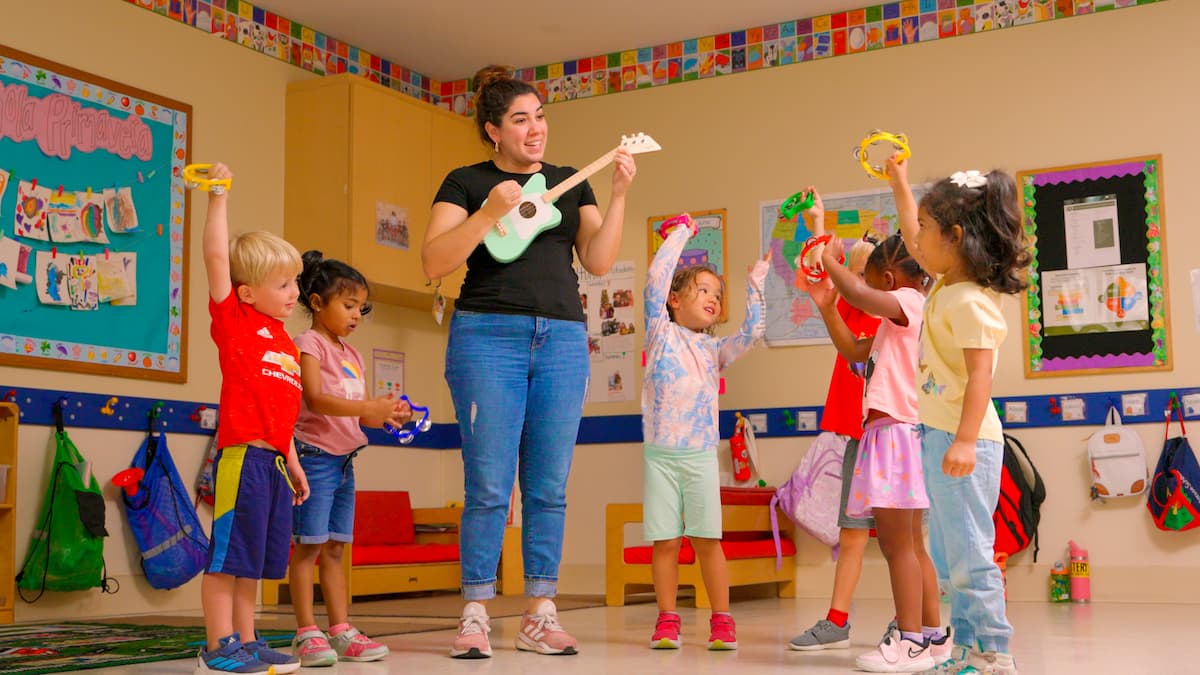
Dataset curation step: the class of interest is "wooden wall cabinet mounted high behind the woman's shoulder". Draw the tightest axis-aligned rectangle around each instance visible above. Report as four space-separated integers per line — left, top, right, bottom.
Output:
283 74 487 310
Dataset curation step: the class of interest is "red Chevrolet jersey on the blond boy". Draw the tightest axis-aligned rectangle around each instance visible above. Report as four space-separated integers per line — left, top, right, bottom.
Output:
209 293 300 456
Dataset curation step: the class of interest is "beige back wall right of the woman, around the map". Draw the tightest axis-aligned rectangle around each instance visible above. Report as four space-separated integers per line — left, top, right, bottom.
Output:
548 2 1200 602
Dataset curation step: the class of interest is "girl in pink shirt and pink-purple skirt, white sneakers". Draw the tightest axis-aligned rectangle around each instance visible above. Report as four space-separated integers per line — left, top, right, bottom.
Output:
810 187 949 673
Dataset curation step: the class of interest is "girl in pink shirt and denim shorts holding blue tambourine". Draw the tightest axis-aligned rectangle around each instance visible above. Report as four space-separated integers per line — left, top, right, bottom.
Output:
288 251 413 668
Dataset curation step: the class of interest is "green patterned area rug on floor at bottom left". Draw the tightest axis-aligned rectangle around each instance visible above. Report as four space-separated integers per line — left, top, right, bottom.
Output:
0 619 293 673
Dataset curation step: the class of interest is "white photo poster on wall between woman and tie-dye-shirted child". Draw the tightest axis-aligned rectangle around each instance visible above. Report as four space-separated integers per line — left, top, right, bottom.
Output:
576 261 638 402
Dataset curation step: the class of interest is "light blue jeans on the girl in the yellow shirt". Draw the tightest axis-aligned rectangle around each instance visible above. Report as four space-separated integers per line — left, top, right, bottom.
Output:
920 424 1013 652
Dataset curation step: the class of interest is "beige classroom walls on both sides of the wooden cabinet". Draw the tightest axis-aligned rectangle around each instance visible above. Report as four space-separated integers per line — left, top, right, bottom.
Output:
0 0 1200 620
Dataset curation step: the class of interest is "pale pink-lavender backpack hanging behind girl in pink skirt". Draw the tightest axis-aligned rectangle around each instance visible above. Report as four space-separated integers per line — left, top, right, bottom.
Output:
770 431 846 556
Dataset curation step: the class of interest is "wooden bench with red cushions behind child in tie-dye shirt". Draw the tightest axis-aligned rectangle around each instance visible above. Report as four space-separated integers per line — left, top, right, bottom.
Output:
605 504 796 608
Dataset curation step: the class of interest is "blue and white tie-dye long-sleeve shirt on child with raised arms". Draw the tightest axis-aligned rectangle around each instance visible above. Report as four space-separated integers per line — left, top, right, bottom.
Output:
642 227 767 450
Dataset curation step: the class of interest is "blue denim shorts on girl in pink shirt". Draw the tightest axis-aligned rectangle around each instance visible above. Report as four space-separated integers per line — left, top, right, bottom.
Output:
292 438 359 544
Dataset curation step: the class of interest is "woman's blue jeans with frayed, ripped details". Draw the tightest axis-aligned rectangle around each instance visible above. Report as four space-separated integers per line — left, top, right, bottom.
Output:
445 311 588 601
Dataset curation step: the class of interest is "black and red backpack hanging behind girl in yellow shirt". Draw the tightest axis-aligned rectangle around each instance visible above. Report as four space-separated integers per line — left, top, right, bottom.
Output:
992 434 1046 562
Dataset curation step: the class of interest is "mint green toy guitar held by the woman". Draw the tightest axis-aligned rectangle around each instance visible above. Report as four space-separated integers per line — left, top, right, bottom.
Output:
484 133 662 263
